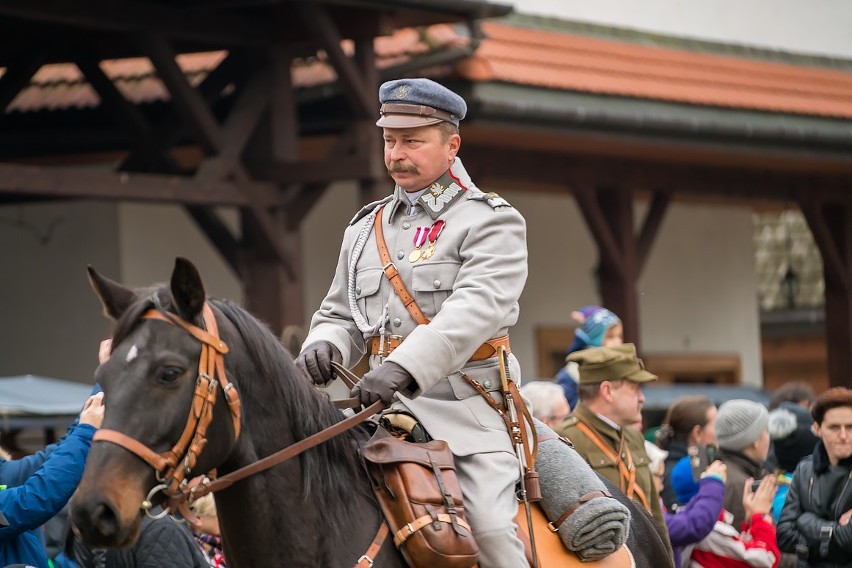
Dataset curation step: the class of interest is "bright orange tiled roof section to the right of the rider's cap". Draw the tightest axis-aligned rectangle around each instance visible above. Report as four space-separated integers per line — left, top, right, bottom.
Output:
459 21 852 118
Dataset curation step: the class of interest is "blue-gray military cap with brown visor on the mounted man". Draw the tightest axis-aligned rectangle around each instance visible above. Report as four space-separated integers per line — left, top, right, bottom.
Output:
376 79 467 128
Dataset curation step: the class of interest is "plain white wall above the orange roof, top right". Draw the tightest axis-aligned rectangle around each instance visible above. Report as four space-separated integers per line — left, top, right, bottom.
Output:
509 0 852 58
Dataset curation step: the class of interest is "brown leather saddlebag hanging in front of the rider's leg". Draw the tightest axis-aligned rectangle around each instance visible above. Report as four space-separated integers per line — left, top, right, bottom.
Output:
362 435 478 568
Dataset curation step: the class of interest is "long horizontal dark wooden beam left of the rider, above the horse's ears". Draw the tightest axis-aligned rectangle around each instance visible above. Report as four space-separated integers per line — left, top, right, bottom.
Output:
0 162 281 207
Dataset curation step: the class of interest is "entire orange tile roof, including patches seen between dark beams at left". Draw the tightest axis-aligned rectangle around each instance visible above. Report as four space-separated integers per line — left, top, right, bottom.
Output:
6 21 852 118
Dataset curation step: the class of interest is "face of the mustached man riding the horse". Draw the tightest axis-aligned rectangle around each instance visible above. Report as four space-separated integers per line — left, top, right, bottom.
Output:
384 126 461 192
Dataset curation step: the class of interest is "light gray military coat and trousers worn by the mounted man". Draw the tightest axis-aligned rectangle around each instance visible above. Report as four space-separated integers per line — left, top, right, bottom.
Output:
304 158 527 568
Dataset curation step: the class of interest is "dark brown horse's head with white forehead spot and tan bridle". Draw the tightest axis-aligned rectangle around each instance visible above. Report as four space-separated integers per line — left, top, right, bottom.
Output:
71 258 240 547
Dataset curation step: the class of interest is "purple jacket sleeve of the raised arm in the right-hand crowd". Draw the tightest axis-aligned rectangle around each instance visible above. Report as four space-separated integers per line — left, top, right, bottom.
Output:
665 477 725 547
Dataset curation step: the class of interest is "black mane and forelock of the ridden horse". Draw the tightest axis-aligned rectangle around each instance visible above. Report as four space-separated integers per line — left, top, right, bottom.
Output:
108 287 371 533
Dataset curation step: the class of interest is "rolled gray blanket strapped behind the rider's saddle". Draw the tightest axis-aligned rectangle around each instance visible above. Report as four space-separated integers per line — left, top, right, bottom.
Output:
533 418 630 562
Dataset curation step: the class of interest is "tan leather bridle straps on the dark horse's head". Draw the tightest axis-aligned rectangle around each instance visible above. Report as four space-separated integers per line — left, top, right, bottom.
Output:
92 302 240 514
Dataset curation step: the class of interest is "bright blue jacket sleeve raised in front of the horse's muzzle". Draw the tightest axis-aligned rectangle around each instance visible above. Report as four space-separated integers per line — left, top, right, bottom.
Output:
0 424 95 542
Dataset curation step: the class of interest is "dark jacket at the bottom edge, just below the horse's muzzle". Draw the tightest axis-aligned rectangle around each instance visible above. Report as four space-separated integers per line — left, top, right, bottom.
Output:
73 515 209 568
